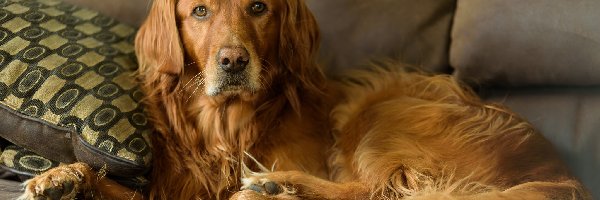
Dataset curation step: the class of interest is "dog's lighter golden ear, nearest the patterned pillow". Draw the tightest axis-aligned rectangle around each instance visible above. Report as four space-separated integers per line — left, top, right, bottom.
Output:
135 0 184 75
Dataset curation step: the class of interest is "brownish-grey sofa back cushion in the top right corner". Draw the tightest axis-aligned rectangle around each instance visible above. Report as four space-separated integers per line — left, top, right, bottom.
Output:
450 0 600 86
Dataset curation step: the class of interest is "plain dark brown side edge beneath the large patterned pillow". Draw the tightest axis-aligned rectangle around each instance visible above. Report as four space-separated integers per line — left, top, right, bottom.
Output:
0 104 149 177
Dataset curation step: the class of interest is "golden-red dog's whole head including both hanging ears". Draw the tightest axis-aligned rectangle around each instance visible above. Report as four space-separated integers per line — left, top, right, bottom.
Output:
136 0 320 97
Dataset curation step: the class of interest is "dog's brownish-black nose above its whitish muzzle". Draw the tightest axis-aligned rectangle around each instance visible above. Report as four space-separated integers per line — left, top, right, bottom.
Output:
217 47 250 74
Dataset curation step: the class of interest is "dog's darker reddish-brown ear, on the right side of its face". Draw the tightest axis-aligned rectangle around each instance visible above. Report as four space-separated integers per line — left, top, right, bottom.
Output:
278 0 322 87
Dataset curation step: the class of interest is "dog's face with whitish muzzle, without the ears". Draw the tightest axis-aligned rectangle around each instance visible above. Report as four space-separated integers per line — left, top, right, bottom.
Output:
176 0 284 96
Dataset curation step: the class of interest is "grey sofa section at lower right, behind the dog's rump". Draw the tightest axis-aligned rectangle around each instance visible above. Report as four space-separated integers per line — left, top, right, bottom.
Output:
483 87 600 197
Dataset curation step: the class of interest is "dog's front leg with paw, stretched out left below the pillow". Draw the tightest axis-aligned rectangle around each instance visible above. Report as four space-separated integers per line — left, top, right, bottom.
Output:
19 163 143 200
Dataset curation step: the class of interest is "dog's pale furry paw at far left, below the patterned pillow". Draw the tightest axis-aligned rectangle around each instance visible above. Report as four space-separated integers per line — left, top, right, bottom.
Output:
18 163 90 200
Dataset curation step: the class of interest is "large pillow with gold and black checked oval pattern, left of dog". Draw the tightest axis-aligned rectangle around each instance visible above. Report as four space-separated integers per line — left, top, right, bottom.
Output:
0 0 152 177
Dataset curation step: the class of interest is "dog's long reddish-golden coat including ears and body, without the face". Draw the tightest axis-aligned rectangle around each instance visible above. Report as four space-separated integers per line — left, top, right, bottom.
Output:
136 0 589 199
